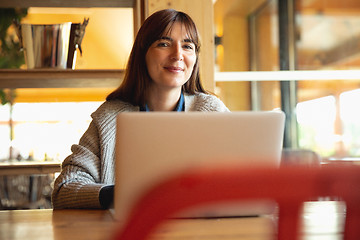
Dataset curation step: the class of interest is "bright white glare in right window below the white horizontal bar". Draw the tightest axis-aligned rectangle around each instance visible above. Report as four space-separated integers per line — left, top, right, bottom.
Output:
296 89 360 158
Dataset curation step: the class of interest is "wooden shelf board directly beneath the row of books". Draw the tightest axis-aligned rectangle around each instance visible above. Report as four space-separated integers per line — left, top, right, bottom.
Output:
0 69 124 88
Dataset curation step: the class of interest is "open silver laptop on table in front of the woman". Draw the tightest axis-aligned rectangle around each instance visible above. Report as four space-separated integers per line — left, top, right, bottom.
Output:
113 111 285 221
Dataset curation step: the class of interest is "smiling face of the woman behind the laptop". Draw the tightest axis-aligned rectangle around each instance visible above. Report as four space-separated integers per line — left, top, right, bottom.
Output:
145 22 197 91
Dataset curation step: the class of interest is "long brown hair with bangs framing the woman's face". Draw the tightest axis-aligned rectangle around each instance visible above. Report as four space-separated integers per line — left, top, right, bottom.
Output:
106 9 207 106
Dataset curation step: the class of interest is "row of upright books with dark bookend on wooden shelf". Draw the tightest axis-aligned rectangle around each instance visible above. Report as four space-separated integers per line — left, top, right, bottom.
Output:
15 19 88 69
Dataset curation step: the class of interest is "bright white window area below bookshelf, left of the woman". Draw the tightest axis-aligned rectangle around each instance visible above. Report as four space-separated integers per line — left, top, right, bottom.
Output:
0 102 101 161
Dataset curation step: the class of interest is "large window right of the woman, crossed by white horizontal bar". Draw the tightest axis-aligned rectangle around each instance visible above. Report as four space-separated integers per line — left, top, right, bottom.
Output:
214 0 360 159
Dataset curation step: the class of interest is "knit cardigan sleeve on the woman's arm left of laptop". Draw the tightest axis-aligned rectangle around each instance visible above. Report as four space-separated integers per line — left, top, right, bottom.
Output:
52 122 104 209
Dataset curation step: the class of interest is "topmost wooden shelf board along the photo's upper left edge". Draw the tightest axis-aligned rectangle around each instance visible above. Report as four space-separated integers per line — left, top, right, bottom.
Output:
0 0 135 8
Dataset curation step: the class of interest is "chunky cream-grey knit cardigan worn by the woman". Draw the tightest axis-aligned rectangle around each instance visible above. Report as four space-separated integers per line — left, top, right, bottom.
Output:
52 93 229 209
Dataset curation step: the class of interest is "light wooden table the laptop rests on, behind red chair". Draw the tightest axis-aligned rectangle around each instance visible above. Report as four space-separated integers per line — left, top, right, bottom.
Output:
0 202 344 240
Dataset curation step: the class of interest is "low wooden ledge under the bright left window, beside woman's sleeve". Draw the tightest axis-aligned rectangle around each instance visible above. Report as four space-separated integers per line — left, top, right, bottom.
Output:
0 161 61 176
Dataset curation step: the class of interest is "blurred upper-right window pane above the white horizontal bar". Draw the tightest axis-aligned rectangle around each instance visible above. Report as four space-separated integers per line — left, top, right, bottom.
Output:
296 6 360 70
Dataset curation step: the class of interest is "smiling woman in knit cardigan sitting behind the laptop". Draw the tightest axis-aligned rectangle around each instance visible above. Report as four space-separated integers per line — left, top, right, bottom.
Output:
52 9 229 209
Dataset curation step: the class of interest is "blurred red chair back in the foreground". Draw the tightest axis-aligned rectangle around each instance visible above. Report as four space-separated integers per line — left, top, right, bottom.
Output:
115 166 360 240
